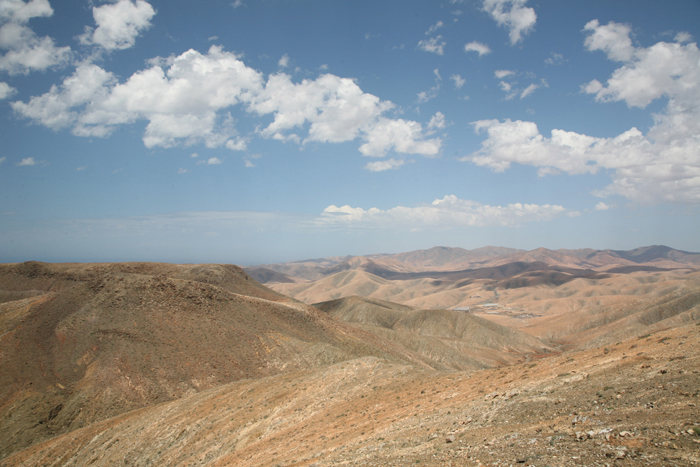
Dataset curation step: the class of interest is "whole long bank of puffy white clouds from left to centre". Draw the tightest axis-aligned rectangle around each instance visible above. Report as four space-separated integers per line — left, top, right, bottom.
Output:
12 46 441 161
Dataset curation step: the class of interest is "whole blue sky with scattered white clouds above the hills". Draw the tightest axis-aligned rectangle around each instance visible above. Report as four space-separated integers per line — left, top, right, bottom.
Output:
0 0 700 265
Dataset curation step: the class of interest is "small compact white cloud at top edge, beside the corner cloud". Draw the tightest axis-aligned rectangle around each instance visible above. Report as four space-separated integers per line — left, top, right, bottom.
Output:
80 0 156 50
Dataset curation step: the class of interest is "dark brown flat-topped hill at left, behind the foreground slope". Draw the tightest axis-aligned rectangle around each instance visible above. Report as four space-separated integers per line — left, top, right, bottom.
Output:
0 263 430 455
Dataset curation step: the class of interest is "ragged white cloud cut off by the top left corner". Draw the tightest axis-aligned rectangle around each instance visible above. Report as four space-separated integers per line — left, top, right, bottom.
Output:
0 0 71 75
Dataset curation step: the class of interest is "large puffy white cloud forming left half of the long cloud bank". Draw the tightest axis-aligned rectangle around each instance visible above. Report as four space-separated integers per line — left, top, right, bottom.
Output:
12 46 263 147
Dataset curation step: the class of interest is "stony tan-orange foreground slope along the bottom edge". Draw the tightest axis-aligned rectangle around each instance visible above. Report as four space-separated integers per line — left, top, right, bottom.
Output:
3 323 700 466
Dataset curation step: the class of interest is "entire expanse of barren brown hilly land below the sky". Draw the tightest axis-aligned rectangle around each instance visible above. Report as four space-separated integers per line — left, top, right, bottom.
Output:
0 246 700 466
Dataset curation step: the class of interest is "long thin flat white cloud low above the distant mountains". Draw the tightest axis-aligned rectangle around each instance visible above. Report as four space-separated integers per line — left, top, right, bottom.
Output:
319 195 580 229
